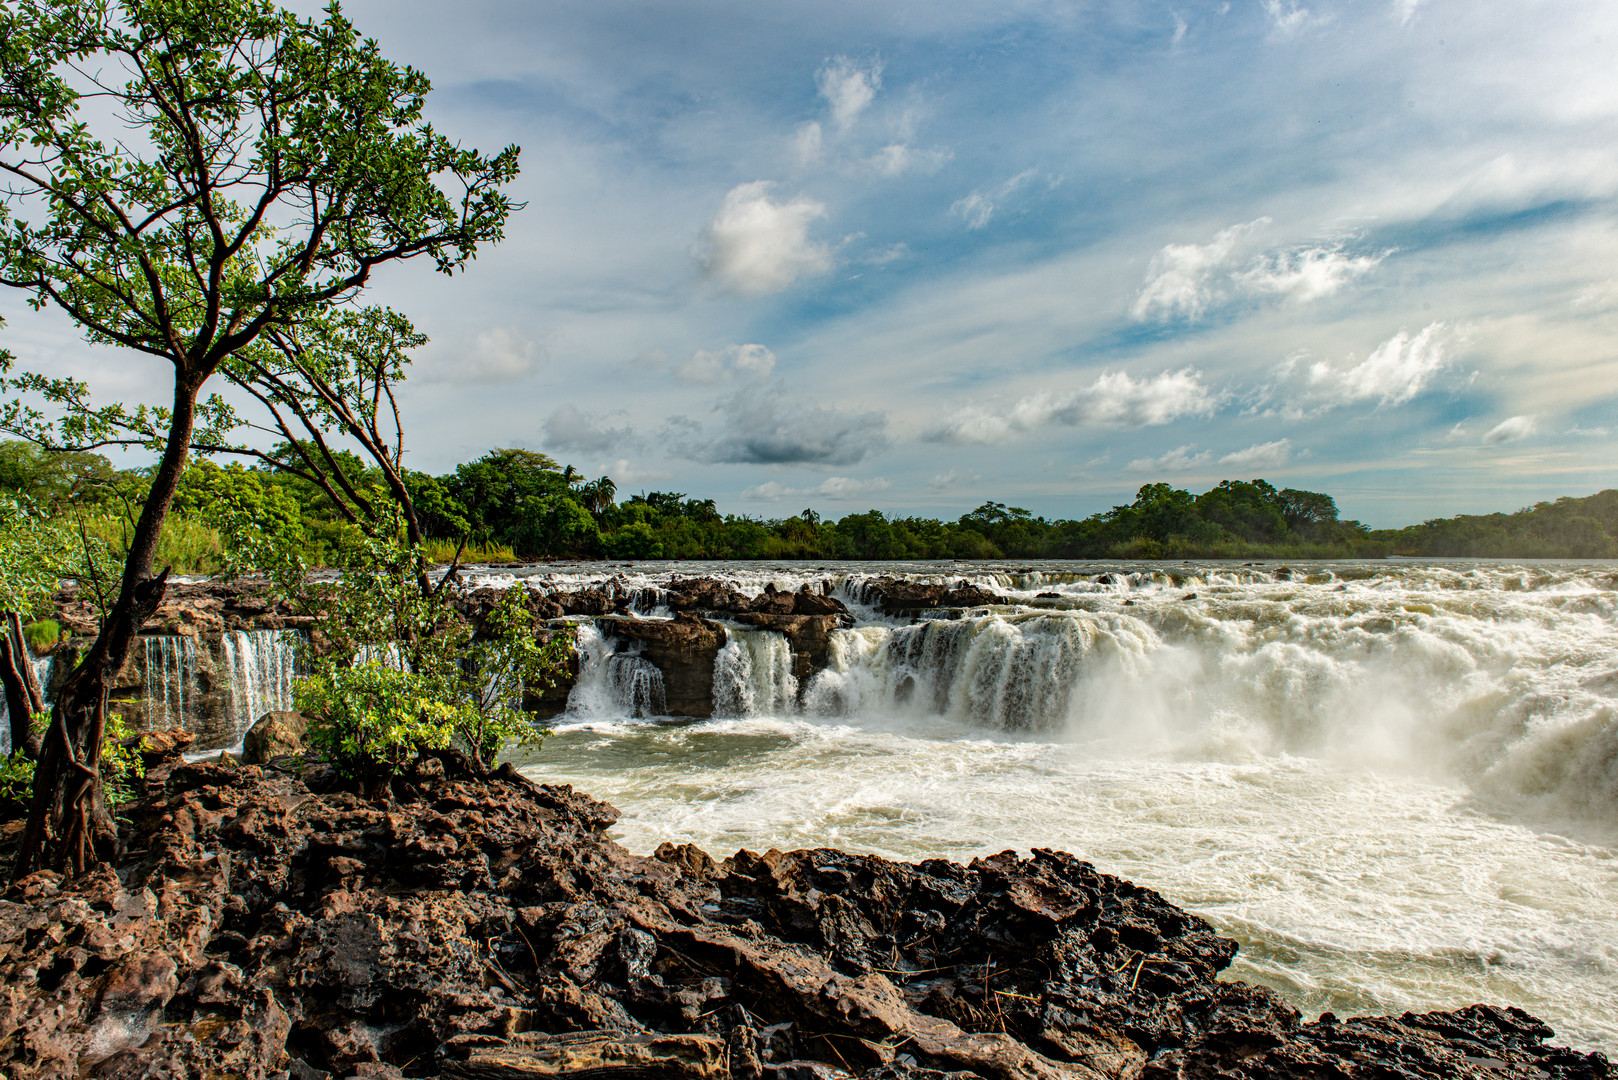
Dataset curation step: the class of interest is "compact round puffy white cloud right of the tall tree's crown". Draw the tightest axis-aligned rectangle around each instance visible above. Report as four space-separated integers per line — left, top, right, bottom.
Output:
697 180 832 296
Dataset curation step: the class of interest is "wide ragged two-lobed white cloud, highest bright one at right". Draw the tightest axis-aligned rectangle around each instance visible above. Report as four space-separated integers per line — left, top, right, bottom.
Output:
1129 217 1391 322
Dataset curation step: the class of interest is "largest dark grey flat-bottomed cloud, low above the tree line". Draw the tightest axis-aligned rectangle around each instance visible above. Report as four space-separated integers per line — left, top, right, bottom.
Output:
665 387 888 465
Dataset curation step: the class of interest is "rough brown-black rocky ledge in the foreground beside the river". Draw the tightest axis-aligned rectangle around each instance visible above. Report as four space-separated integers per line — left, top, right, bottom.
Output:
0 755 1610 1080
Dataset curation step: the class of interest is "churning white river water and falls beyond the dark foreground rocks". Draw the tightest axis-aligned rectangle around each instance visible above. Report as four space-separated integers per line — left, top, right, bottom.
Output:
487 562 1618 1052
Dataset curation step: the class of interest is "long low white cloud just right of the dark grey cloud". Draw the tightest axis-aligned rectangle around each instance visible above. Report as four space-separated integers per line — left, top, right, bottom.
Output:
924 368 1217 444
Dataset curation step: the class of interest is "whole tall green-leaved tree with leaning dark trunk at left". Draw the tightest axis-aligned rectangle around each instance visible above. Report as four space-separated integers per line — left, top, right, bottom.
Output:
0 0 518 876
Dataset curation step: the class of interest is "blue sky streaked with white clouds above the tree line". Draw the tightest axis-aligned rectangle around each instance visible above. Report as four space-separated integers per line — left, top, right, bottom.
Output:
6 0 1618 525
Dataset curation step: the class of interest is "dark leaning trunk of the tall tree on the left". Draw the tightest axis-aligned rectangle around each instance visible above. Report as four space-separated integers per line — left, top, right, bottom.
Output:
11 376 197 881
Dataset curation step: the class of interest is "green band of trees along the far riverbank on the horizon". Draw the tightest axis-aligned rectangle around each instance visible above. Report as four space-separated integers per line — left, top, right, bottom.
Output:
12 440 1618 572
